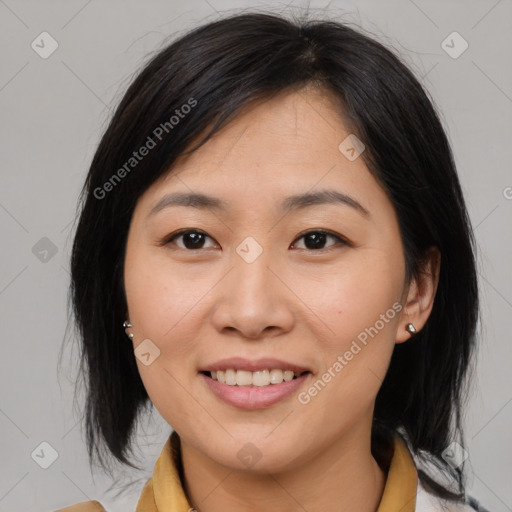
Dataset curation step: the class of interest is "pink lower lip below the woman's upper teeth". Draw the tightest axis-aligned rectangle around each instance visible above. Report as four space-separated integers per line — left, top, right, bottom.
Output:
199 373 311 409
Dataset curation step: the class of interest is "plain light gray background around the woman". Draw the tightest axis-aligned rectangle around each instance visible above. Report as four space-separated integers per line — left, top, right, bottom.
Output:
0 0 512 512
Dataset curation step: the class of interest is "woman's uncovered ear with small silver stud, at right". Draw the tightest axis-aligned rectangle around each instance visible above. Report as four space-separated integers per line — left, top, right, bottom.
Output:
396 247 441 343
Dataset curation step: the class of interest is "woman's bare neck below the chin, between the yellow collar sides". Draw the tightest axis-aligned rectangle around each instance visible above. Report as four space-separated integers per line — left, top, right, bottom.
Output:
181 422 386 512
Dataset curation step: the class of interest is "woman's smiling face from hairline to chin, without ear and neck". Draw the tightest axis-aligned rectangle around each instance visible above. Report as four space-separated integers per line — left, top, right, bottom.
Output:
124 86 412 471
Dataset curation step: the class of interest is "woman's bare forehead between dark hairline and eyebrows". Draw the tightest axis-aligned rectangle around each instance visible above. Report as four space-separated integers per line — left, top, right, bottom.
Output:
134 89 385 220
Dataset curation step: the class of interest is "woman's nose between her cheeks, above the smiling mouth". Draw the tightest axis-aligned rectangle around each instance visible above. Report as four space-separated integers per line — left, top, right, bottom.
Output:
212 251 294 340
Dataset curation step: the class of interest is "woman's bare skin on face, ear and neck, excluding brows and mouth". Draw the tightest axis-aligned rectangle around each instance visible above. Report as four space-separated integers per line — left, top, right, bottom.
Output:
124 88 440 512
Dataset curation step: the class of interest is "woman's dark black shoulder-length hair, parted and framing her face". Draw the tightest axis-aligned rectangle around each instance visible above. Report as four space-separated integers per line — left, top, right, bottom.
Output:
65 8 479 500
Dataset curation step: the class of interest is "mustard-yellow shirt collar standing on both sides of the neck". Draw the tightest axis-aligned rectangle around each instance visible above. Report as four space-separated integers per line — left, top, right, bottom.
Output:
136 432 418 512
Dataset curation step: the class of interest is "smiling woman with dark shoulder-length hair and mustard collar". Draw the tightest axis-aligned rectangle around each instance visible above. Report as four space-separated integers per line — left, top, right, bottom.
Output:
58 9 490 512
